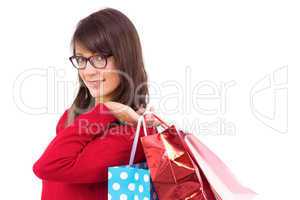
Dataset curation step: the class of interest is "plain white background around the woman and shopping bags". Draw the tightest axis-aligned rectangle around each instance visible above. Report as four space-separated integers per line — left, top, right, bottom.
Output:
0 0 300 200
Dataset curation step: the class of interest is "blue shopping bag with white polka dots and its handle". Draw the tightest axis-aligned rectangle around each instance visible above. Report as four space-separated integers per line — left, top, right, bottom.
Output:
108 115 158 200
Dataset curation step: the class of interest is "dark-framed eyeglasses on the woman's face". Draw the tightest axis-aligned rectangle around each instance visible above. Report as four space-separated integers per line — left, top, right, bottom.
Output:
69 55 111 69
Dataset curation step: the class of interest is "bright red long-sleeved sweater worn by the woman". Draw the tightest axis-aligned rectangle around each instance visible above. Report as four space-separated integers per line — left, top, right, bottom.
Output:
33 103 156 200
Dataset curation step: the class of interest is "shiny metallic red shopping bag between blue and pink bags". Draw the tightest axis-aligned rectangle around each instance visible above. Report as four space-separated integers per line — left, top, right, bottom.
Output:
141 114 216 200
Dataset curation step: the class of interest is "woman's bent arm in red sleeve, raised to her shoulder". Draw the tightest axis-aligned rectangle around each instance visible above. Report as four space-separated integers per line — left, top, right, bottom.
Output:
33 104 148 183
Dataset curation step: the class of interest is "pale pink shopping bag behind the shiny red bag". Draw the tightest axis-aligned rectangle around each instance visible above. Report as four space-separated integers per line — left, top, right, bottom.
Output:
184 133 256 200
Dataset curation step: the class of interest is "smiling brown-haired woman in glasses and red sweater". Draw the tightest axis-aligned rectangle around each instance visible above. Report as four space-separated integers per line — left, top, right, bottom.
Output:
33 8 158 200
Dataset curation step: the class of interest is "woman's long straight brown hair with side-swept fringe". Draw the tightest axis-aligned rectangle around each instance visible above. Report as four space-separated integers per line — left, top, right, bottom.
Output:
67 8 149 125
